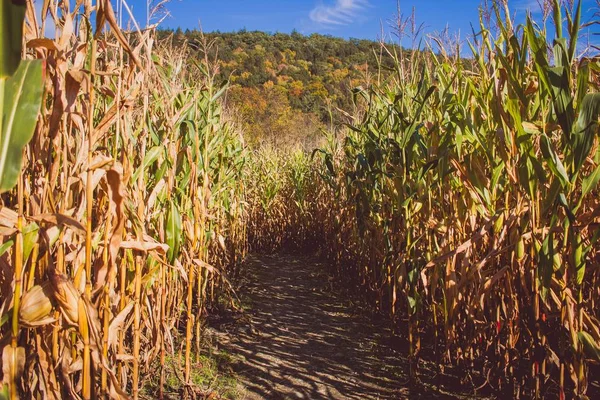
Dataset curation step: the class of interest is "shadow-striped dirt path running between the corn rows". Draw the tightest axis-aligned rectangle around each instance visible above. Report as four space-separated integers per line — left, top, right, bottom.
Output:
206 256 438 400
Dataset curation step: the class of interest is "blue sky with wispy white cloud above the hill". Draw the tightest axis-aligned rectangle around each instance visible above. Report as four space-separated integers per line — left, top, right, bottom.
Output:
119 0 599 44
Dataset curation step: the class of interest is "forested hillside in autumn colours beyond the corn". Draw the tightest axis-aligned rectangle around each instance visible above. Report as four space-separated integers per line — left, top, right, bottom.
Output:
161 30 399 147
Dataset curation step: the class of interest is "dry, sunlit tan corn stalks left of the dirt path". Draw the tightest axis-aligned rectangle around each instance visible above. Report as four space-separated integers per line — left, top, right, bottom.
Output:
0 0 247 399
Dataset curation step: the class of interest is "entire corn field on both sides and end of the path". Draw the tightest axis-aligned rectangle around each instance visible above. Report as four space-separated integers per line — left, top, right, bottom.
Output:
0 0 600 400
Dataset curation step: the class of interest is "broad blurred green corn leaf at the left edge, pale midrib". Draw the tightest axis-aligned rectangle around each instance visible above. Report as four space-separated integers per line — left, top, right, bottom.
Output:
0 60 43 193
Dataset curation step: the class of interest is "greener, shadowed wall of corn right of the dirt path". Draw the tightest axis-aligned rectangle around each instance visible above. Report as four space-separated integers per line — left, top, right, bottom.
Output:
308 1 600 398
